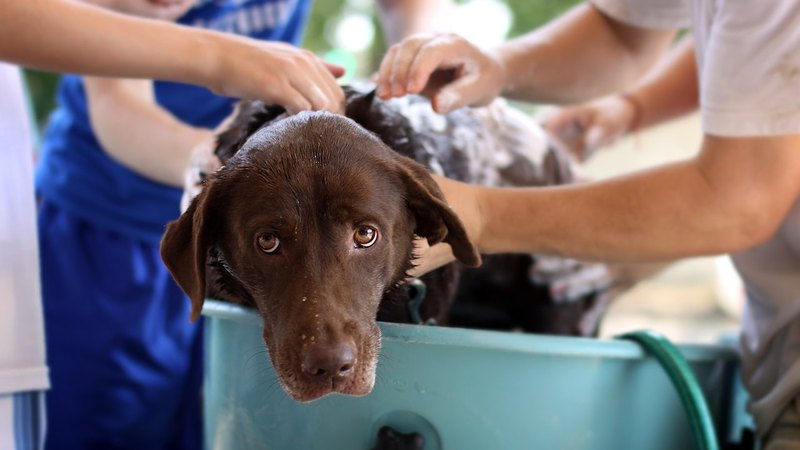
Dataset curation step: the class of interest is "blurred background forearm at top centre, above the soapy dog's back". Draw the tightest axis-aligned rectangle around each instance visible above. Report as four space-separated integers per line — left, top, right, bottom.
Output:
376 0 452 45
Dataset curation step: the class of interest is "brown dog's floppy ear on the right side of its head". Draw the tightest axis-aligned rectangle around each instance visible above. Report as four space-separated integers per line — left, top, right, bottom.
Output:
397 155 481 267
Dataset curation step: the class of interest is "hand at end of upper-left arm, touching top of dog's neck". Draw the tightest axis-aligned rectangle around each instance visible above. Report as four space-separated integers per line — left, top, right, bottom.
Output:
203 35 344 114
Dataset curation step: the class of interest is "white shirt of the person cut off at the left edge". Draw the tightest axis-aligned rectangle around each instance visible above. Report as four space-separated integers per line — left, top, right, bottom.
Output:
0 63 49 395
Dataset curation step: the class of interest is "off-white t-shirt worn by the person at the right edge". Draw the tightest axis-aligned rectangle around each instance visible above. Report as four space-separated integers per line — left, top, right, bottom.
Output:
592 0 800 435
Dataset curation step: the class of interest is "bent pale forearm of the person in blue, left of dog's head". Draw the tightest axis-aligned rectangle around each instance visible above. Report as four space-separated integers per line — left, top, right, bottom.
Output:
85 77 212 187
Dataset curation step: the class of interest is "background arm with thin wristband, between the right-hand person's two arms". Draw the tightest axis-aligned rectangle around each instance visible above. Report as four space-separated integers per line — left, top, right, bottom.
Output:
545 38 699 159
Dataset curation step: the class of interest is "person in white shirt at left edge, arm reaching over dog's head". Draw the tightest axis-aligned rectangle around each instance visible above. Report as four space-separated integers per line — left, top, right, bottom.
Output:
0 0 344 450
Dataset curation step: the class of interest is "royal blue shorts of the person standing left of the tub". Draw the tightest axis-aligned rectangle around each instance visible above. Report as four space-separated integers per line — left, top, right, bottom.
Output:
39 201 202 450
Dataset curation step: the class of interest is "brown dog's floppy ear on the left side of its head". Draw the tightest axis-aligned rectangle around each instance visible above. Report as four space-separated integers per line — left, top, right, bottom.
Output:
161 179 223 322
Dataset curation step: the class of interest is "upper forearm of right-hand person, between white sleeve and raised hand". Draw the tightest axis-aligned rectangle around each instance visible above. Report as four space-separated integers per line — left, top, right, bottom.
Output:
497 4 675 103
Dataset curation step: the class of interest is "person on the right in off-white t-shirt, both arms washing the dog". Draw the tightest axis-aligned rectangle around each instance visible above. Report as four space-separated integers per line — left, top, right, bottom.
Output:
378 0 800 450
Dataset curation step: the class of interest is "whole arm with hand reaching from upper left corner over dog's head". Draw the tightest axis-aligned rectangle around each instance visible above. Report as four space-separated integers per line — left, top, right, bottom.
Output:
0 0 344 111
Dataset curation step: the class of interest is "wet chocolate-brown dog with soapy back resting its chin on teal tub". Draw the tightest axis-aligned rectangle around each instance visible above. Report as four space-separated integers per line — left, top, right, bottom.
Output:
161 86 632 401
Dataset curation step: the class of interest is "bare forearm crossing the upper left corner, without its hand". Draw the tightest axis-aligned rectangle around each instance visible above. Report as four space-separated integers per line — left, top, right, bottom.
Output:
0 0 217 86
